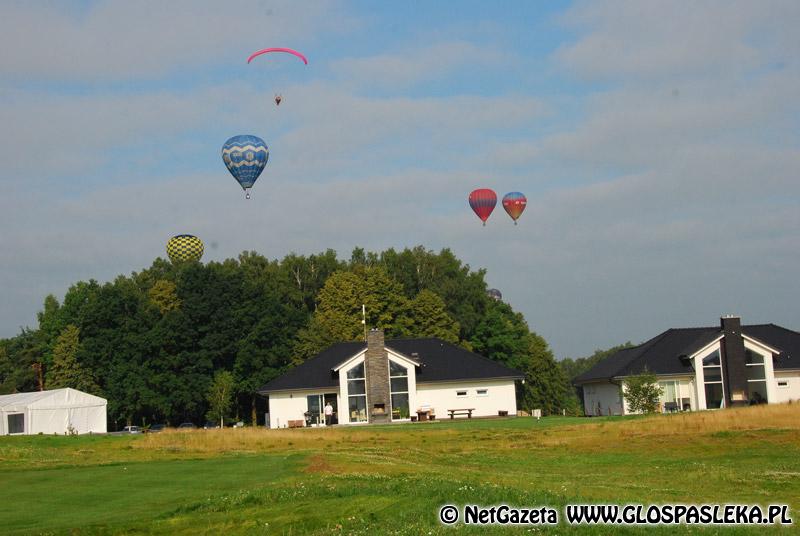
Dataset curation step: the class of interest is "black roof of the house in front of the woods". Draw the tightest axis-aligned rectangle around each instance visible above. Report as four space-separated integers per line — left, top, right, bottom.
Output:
258 338 524 393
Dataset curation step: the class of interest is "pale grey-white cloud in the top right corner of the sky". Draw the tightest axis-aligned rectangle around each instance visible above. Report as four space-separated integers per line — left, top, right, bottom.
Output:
558 0 800 81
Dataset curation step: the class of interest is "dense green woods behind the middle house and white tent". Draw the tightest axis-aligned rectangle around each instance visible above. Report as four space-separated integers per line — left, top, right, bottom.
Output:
0 246 578 429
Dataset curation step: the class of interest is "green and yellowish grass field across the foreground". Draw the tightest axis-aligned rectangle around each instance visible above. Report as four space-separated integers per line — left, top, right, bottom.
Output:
0 404 800 534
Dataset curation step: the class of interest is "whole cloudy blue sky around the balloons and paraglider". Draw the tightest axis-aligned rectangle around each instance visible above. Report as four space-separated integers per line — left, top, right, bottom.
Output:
0 0 800 357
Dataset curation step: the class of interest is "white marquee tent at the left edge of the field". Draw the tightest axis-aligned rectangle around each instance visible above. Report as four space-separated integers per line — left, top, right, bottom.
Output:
0 388 107 435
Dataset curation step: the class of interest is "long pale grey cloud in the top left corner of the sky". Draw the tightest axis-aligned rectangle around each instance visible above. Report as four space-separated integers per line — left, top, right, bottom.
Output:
0 0 353 81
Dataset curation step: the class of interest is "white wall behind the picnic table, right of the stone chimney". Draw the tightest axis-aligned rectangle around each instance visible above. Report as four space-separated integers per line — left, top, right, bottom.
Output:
416 380 517 419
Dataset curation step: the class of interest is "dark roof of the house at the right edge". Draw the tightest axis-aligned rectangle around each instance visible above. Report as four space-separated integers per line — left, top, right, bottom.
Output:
572 324 800 384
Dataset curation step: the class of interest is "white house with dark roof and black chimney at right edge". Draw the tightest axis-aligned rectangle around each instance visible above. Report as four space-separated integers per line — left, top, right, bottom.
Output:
573 316 800 415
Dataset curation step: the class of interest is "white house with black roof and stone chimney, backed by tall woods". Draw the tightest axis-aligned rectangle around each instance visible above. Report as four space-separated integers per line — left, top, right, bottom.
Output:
259 330 523 428
